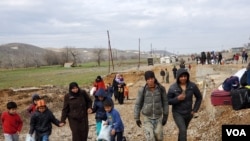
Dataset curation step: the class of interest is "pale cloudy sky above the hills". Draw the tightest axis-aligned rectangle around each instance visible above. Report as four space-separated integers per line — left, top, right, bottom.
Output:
0 0 250 54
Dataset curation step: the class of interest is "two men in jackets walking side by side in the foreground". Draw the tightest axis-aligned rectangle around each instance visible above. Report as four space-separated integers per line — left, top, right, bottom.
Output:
134 68 202 141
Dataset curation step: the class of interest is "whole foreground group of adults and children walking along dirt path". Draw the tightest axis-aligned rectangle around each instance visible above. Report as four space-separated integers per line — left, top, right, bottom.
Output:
1 68 202 141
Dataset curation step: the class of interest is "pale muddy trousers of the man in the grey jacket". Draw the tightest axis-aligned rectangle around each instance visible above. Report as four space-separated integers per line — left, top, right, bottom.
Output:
143 116 163 141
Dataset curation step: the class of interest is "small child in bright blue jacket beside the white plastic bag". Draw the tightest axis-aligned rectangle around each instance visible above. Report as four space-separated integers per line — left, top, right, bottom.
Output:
103 99 124 141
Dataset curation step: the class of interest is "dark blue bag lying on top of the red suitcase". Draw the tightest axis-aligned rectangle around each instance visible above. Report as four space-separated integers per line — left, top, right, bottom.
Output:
222 76 240 91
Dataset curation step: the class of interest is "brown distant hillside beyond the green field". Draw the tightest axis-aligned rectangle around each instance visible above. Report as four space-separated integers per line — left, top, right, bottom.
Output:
0 43 153 68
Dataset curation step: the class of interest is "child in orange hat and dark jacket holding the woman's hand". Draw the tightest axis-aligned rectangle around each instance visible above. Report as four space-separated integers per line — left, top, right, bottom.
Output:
29 99 64 141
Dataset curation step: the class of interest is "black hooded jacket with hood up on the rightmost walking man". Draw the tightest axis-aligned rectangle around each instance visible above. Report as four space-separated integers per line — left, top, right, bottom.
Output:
168 68 202 114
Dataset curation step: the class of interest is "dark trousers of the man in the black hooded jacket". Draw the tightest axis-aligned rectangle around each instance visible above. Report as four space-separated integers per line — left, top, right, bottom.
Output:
173 112 193 141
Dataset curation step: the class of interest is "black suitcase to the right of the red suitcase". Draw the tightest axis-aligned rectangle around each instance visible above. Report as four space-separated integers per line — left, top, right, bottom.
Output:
231 87 250 110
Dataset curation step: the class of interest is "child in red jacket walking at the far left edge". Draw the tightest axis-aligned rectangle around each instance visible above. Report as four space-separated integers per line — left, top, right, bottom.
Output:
1 101 23 141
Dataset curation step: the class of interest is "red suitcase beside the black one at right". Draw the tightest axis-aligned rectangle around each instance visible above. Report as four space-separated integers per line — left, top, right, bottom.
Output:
211 89 232 106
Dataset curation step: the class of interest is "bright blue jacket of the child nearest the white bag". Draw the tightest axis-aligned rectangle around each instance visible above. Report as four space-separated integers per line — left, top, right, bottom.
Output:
107 108 124 132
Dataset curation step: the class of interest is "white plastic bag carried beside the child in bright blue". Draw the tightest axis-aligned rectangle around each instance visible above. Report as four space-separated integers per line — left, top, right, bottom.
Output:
97 121 111 141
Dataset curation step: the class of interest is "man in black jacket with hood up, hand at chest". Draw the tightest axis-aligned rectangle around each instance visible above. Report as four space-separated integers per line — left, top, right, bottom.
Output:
167 68 202 141
